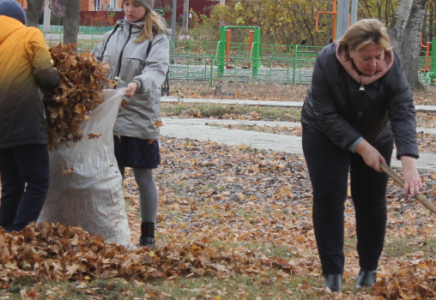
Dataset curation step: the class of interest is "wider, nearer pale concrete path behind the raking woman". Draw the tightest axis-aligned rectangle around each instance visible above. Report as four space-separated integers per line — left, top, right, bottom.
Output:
161 118 436 172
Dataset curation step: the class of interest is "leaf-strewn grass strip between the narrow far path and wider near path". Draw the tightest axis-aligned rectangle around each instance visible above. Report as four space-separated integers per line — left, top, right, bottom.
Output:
161 102 301 122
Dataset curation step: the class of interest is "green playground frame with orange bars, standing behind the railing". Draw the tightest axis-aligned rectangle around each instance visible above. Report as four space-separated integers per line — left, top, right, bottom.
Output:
217 26 260 77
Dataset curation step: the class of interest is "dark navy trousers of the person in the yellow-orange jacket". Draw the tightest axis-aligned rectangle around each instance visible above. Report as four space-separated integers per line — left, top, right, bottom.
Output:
0 145 50 232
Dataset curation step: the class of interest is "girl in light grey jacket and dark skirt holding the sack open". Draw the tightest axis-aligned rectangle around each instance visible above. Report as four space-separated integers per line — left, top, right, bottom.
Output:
92 0 169 247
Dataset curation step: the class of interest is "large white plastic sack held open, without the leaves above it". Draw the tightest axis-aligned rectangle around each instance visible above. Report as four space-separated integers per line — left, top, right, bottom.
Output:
38 89 134 248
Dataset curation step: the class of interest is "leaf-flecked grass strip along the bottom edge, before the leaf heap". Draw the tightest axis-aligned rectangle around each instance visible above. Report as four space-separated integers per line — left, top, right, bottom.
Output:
0 270 330 300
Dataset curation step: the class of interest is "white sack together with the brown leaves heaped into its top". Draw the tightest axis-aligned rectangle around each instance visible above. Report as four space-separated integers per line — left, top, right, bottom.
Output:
38 44 134 248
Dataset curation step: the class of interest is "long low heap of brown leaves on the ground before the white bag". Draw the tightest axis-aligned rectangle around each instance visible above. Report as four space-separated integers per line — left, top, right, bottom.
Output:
0 222 293 288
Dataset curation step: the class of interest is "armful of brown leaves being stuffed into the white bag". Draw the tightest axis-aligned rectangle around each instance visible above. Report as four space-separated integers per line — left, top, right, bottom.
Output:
43 44 116 148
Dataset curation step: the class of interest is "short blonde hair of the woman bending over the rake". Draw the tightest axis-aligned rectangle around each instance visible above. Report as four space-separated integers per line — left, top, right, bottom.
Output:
337 19 392 60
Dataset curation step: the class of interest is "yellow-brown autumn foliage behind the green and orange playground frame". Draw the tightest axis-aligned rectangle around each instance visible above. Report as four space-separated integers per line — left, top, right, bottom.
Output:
190 0 398 46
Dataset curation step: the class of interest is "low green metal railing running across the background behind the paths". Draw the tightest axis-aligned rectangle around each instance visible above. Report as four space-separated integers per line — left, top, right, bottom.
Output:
40 28 433 85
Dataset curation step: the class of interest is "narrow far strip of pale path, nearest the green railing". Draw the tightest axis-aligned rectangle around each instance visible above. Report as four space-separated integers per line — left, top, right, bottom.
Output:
161 96 436 112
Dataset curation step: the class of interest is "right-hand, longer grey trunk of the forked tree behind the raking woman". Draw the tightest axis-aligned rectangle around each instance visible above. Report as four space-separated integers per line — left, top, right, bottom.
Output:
402 0 428 90
